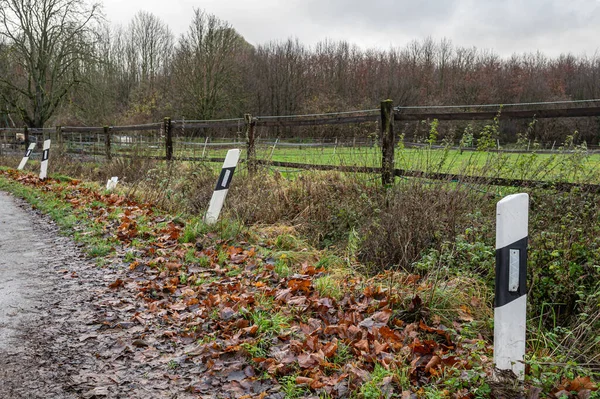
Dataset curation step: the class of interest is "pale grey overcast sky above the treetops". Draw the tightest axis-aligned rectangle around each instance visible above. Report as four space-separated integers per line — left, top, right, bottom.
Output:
101 0 600 56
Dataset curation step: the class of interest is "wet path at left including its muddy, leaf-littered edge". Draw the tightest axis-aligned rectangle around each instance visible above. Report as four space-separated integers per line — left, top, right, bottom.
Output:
0 192 189 399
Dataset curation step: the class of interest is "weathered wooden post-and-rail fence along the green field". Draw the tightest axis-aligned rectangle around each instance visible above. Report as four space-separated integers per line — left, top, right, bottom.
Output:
0 100 600 192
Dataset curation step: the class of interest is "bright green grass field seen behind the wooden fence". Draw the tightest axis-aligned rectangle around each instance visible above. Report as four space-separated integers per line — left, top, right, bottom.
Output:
54 139 600 184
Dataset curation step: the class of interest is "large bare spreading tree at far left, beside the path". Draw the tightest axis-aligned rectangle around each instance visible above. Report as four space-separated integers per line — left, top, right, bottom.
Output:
0 0 99 127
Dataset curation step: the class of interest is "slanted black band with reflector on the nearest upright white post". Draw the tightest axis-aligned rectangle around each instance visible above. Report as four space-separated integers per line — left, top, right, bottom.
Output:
494 237 527 308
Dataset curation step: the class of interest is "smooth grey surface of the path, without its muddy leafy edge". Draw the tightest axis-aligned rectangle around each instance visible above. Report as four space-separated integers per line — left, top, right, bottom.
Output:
0 192 81 398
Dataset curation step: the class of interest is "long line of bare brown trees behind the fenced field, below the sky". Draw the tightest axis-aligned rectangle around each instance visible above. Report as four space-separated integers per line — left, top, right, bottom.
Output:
0 0 600 143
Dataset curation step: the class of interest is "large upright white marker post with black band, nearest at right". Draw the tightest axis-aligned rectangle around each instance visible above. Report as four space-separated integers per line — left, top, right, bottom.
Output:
494 194 529 380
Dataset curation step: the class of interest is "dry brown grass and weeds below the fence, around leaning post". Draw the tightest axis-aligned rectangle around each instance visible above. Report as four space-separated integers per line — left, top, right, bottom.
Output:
159 163 486 270
